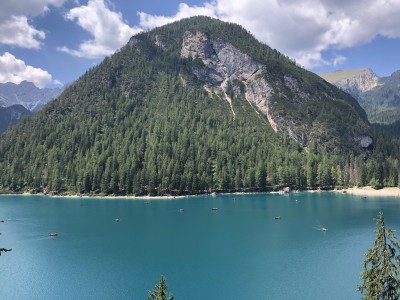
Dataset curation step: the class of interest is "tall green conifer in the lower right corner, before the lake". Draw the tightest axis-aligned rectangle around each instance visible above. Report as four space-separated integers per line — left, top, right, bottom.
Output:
358 212 400 300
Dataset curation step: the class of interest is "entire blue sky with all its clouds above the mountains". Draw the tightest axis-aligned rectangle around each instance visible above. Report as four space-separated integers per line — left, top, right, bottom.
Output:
0 0 400 87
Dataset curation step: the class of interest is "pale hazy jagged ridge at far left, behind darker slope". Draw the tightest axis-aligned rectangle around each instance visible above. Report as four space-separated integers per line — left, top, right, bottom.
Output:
0 81 62 112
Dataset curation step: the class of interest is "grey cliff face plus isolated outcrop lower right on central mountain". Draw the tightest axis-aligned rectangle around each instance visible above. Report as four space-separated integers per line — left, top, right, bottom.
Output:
181 31 372 148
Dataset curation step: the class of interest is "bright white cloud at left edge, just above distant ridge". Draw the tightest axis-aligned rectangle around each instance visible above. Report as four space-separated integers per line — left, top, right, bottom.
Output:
0 52 52 88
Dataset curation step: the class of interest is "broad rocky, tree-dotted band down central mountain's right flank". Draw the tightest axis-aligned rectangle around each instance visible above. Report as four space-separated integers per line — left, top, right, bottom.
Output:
180 30 372 149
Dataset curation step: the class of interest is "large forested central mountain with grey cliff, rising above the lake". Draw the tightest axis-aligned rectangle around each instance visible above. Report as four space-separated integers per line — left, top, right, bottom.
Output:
0 17 400 195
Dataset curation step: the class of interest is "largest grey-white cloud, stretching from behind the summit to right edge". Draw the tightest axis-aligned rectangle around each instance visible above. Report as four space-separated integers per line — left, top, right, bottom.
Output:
139 0 400 68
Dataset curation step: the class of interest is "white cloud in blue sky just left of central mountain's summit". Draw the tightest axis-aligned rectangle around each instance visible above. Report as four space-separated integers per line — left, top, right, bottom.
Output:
58 0 142 58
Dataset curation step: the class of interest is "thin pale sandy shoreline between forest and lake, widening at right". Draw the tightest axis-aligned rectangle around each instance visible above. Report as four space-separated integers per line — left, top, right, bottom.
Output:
0 186 400 200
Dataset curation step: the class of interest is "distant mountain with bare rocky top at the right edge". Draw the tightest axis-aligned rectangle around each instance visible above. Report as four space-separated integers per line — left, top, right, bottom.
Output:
319 68 400 124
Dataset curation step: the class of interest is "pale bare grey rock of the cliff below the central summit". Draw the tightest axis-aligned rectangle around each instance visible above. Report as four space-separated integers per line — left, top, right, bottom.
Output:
181 31 307 145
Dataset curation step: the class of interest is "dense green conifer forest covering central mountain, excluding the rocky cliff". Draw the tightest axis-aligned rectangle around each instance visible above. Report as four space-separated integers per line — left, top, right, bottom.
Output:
0 17 400 195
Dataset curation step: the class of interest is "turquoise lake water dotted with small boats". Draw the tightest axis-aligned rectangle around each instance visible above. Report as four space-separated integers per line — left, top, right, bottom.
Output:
0 193 400 300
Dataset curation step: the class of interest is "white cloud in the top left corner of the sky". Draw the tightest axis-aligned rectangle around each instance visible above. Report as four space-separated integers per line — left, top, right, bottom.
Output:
0 0 65 49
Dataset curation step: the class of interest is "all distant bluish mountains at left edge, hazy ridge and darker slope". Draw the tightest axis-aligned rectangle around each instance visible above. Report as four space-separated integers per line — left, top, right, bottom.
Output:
0 81 63 133
